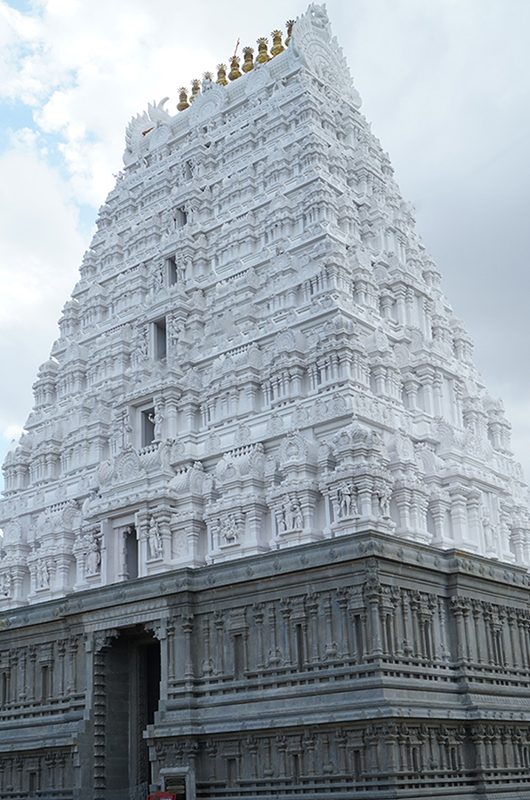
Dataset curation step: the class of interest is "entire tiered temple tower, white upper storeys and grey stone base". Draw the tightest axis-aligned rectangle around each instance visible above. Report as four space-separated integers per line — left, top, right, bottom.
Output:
0 5 530 800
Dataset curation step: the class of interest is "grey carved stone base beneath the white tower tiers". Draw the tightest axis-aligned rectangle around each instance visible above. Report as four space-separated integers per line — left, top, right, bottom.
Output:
0 533 530 800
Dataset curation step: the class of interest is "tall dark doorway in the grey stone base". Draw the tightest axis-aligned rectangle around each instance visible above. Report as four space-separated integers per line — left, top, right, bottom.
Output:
104 626 160 800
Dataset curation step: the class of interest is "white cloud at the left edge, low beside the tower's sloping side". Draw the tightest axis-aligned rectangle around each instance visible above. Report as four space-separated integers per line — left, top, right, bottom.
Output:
0 134 88 439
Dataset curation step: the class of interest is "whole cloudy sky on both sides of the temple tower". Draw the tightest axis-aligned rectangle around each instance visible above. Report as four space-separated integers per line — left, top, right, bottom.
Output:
0 0 530 484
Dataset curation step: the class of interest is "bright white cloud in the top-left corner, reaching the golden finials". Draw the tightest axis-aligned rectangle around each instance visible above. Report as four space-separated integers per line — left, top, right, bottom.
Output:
0 0 219 206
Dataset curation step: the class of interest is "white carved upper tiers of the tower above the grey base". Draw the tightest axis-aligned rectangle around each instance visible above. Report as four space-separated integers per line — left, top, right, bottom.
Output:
0 5 530 609
